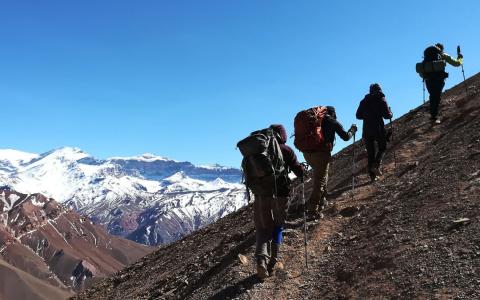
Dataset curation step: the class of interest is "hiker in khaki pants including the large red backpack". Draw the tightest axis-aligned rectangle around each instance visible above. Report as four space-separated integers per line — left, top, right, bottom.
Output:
294 106 357 219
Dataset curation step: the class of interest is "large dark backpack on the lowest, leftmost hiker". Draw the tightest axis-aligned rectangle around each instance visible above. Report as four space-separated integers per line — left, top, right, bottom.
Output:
237 128 286 196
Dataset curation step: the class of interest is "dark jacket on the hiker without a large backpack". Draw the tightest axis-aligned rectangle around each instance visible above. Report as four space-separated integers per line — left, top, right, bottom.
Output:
357 91 393 138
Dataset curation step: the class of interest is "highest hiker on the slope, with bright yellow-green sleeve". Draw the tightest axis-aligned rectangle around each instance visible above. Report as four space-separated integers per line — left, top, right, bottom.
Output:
421 43 463 124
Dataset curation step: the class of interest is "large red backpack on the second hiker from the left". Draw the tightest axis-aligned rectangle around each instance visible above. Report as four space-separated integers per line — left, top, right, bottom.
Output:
293 106 327 152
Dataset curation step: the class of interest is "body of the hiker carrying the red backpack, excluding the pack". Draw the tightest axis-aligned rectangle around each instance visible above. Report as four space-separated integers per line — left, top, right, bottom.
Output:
303 106 357 219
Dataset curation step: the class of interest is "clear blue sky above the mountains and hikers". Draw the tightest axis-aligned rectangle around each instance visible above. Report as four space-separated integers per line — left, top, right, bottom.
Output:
0 0 480 167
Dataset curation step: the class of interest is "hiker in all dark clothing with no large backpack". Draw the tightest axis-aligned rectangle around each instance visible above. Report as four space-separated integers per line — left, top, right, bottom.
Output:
357 83 393 181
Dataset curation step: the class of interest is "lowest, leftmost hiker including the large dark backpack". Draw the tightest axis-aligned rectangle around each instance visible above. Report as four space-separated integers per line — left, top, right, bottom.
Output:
237 124 304 279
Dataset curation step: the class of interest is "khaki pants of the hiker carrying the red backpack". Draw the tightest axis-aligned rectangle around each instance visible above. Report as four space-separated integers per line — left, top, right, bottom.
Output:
303 151 332 212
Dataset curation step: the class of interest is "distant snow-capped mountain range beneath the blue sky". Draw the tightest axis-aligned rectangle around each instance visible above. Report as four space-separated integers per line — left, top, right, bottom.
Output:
0 147 246 245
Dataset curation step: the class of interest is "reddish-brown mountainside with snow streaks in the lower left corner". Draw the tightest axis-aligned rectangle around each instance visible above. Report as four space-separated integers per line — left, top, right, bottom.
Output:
0 187 153 299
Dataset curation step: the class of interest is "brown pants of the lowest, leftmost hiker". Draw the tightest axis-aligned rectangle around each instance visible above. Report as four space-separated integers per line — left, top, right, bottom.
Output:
253 195 288 259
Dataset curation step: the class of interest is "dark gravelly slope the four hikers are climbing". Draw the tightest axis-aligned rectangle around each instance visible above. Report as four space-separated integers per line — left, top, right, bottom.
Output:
74 74 480 299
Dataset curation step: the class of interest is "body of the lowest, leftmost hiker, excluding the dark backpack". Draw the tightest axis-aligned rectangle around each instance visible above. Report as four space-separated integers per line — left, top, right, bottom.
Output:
254 124 304 279
